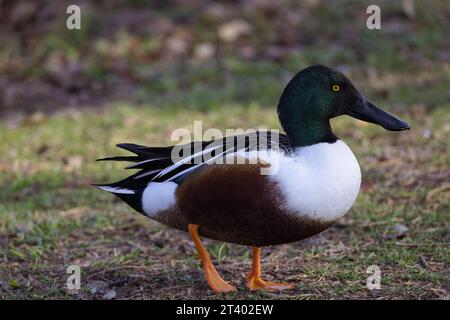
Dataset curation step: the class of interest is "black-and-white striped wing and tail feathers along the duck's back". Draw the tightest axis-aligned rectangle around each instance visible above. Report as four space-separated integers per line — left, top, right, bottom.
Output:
96 131 292 194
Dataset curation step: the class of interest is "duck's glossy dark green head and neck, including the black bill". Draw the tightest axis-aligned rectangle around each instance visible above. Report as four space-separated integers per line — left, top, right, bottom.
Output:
278 65 409 147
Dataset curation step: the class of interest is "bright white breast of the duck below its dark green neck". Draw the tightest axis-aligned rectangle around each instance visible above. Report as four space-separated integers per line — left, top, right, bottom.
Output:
269 140 361 221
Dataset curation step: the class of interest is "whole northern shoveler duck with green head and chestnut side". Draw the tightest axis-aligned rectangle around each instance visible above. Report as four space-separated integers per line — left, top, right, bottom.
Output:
96 65 409 292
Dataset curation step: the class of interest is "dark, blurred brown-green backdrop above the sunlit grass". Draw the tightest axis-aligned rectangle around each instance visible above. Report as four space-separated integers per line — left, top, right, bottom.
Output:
0 0 450 111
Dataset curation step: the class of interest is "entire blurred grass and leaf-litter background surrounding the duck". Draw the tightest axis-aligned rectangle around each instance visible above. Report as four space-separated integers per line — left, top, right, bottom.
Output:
0 0 450 299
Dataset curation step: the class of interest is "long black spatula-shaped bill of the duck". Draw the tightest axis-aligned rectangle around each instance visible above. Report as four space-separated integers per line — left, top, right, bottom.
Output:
347 98 410 131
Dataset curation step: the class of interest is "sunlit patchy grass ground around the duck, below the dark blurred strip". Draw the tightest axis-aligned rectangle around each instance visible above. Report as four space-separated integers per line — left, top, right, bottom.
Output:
0 91 450 299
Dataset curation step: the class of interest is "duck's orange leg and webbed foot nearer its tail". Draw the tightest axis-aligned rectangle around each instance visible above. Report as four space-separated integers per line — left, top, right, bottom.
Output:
188 224 236 293
